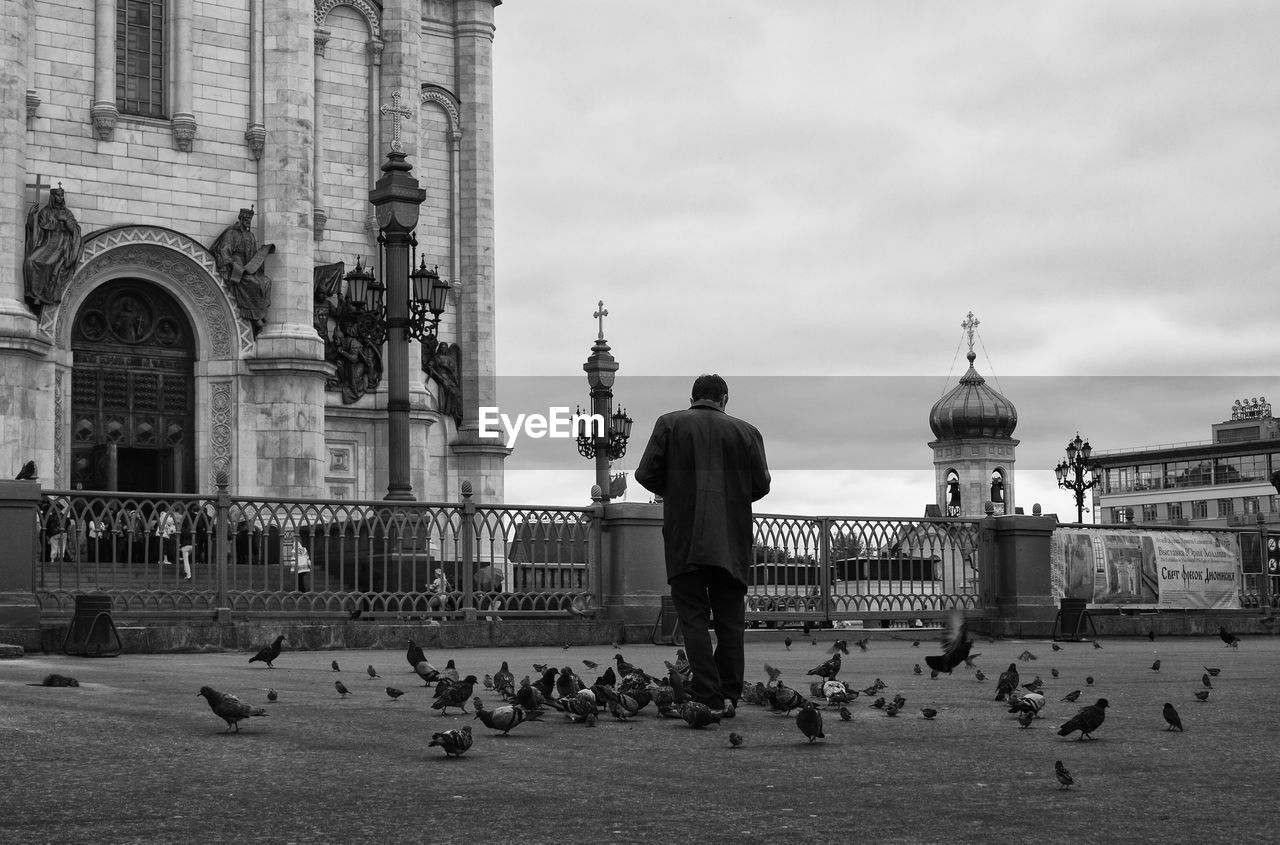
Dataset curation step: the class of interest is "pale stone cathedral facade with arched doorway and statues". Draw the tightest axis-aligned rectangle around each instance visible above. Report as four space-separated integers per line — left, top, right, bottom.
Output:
0 0 506 502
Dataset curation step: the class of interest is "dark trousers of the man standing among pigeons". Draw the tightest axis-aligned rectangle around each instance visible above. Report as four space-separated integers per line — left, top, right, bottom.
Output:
671 566 746 709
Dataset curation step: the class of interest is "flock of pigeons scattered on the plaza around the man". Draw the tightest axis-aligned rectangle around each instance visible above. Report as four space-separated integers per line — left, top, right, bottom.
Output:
185 612 1239 789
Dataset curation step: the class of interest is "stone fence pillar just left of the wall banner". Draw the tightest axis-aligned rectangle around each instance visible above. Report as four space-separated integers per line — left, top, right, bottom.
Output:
989 516 1057 636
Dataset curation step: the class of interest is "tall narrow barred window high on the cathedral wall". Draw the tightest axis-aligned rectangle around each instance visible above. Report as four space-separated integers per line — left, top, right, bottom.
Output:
115 0 165 118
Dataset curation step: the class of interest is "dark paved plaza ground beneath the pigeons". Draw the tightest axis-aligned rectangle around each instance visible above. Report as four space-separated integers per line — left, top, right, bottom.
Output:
0 631 1280 844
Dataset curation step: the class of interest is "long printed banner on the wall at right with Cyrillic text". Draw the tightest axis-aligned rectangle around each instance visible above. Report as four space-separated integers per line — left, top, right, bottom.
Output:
1050 529 1240 608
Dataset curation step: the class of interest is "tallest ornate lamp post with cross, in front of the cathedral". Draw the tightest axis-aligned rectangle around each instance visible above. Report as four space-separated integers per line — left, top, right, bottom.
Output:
360 91 449 502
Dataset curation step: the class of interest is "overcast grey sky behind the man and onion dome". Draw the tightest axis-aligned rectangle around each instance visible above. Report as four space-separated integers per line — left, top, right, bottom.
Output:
481 0 1280 519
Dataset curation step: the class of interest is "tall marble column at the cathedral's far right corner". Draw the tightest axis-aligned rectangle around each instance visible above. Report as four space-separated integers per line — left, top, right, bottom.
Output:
451 0 509 503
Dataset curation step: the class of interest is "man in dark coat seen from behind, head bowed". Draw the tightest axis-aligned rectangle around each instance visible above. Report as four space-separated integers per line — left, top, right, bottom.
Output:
635 375 769 716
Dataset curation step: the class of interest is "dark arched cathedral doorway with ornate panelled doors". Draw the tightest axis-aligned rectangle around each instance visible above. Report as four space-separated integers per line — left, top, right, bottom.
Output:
70 279 196 493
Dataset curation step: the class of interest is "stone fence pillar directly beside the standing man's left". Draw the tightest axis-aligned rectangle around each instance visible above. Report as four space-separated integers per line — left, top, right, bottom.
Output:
600 502 669 640
